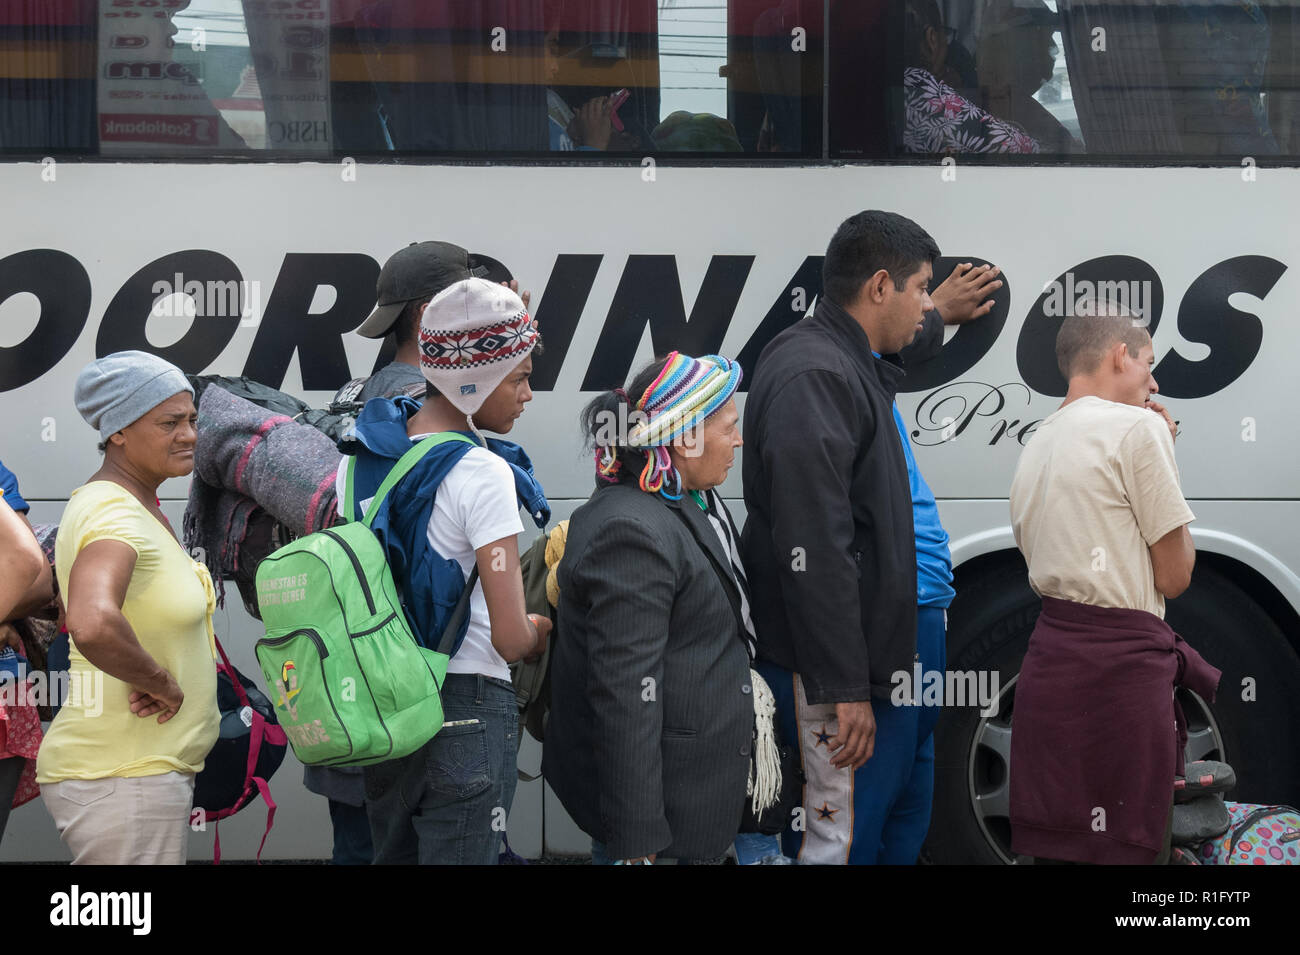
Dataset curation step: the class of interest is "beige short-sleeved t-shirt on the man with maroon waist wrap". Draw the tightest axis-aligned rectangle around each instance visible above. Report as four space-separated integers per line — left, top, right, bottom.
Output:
1011 396 1196 618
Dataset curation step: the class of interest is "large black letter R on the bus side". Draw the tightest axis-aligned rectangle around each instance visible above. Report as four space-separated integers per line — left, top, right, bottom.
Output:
243 252 380 391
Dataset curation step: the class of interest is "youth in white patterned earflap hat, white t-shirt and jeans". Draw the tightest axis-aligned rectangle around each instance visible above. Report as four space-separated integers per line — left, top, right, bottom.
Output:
338 278 550 865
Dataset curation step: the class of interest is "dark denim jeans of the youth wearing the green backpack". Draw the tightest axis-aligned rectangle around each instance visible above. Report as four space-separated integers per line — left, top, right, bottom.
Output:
365 673 519 865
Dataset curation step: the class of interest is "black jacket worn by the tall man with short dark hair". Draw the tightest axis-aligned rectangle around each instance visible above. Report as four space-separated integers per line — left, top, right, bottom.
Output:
741 299 943 703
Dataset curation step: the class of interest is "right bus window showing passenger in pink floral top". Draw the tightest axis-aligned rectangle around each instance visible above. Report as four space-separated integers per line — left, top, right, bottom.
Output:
828 0 1300 164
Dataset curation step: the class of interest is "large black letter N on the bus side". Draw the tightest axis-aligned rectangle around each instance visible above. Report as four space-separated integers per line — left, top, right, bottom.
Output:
582 255 754 391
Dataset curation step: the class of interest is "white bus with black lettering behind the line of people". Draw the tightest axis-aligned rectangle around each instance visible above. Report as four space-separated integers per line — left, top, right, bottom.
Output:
0 0 1300 863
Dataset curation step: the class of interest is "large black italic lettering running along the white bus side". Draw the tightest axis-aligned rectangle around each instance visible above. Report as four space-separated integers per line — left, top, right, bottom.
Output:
0 248 1287 402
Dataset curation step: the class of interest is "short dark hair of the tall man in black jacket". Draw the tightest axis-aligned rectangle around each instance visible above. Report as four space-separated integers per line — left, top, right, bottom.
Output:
822 209 939 305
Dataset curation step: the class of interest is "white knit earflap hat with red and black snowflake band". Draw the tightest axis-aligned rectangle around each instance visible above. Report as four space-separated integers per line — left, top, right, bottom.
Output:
420 278 537 417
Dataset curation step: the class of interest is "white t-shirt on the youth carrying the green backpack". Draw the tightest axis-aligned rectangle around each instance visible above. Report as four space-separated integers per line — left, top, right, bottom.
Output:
335 434 524 680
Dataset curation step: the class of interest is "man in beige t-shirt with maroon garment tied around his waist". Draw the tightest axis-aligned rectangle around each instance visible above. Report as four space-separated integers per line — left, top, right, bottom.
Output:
1010 303 1221 864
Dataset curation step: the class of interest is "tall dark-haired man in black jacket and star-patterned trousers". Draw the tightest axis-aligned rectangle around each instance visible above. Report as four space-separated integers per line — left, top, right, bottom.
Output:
741 212 946 864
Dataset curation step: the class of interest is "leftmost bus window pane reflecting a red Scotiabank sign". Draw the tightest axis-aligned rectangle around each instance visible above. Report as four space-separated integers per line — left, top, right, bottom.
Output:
0 0 330 157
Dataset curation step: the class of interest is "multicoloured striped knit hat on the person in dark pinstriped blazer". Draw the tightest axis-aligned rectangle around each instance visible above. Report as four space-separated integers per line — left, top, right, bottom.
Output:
595 352 741 500
